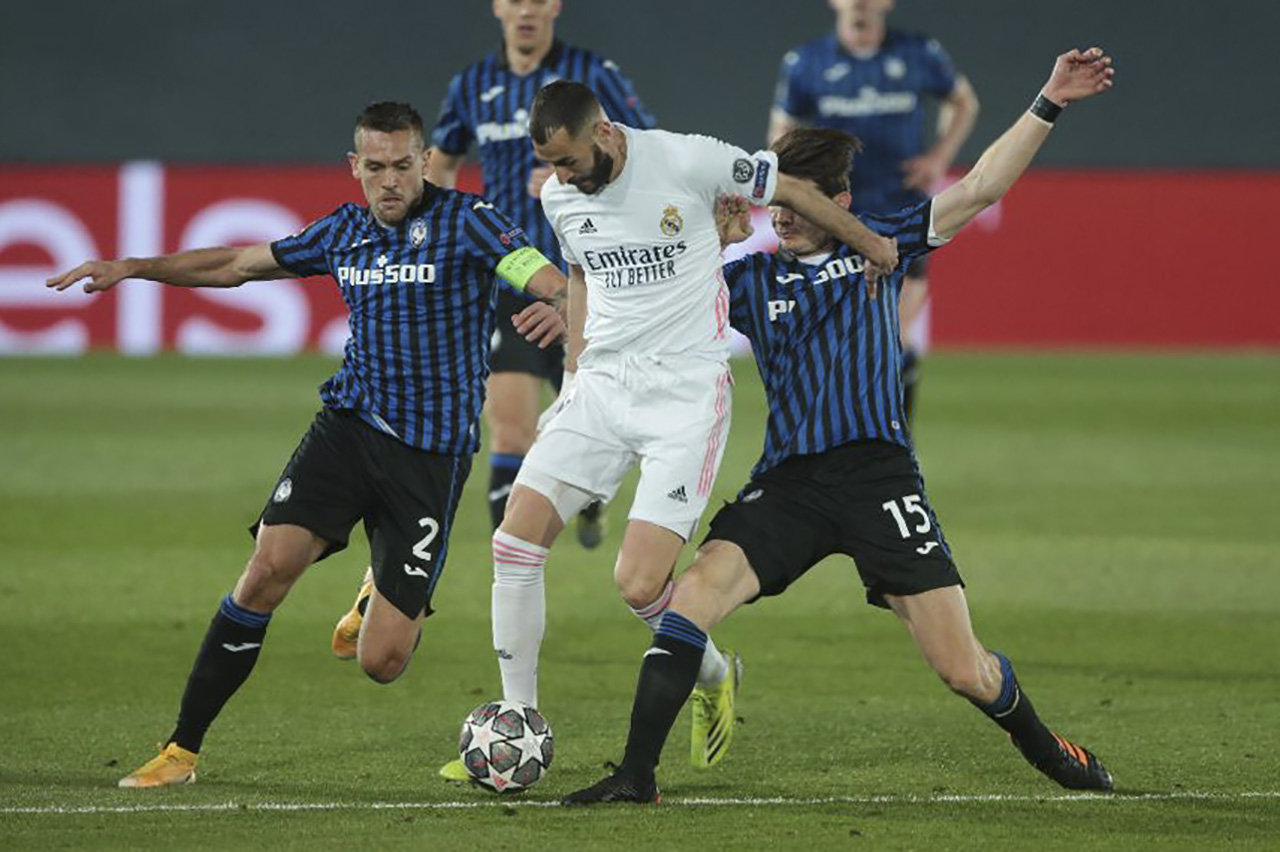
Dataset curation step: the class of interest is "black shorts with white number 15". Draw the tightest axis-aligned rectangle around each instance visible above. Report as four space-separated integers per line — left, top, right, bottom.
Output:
704 441 964 606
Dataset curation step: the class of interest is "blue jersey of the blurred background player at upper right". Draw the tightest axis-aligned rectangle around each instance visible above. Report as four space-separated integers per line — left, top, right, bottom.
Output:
773 29 956 212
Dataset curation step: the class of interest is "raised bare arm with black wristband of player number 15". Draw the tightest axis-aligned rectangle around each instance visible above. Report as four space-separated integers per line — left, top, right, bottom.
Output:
933 47 1115 239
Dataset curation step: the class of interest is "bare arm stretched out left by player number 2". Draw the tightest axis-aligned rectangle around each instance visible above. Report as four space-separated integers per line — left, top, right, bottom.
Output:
45 243 292 293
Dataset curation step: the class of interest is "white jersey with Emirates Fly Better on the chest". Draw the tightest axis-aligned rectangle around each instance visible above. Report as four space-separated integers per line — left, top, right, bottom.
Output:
541 125 778 361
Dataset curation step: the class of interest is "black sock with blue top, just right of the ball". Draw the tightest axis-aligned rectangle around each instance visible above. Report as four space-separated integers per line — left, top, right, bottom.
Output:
622 609 707 775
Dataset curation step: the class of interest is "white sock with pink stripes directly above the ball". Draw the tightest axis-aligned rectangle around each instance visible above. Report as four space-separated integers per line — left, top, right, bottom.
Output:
490 530 548 707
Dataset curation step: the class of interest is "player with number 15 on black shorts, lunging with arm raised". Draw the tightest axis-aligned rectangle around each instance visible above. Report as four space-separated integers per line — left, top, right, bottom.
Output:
564 47 1114 805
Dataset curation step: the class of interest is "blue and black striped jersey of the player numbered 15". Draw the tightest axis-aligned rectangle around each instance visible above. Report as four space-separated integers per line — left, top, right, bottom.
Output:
723 201 941 478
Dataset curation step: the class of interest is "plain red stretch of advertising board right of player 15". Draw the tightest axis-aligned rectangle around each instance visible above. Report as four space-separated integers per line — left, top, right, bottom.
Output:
931 170 1280 348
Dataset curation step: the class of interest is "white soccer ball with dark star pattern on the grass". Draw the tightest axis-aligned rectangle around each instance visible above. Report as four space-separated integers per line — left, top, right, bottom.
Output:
458 701 556 793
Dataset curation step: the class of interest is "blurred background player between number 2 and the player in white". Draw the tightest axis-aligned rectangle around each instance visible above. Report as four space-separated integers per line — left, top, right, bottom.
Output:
429 0 655 539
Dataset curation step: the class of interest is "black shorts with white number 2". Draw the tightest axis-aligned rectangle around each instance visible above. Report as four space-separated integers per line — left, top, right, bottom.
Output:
250 408 471 618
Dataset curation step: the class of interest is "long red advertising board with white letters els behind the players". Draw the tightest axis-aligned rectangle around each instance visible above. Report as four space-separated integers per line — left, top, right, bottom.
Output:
0 162 1280 354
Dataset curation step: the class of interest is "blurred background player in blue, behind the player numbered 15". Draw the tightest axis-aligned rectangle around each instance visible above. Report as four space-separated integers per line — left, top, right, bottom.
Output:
769 0 978 421
